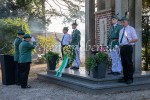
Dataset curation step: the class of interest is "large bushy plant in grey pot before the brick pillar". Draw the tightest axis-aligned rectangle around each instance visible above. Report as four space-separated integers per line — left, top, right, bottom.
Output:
85 52 110 79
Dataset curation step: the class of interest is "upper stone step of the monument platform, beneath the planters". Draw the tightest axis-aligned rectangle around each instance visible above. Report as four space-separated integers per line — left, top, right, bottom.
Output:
47 70 150 84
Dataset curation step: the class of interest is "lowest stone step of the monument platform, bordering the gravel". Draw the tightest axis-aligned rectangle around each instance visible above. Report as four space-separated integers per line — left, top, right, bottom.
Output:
38 72 150 94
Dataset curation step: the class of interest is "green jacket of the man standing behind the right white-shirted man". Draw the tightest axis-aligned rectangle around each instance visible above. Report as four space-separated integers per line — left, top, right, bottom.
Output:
107 24 122 49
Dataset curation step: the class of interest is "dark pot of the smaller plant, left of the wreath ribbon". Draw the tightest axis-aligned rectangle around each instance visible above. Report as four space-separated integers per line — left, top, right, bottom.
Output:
47 57 58 70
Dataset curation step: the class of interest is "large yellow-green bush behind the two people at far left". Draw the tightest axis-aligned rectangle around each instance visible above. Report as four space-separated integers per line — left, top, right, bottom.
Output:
0 18 30 55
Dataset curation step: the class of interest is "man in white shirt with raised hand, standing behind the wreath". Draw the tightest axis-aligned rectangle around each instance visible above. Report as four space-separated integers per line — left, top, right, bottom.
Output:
55 27 71 57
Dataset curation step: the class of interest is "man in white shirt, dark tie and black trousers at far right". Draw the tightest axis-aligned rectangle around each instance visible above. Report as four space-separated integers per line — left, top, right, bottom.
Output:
119 17 138 84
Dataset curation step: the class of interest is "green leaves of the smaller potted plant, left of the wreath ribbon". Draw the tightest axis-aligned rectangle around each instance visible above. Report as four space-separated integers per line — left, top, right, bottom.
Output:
43 51 60 63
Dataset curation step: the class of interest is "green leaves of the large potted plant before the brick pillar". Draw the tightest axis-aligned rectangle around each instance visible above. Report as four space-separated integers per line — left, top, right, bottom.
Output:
85 52 111 71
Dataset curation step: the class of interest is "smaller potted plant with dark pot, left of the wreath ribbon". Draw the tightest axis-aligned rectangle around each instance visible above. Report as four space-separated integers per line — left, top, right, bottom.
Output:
43 51 60 70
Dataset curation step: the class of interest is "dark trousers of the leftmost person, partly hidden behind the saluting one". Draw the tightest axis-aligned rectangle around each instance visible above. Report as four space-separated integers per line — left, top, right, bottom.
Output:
15 61 20 85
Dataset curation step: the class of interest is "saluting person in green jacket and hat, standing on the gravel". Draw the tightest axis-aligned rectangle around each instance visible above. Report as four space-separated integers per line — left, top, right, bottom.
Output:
19 34 36 88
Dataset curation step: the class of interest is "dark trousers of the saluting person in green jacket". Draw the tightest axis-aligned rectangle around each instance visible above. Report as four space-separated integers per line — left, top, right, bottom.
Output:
20 62 31 87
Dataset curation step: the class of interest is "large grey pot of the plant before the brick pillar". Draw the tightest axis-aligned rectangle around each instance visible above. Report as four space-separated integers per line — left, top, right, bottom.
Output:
90 62 107 79
